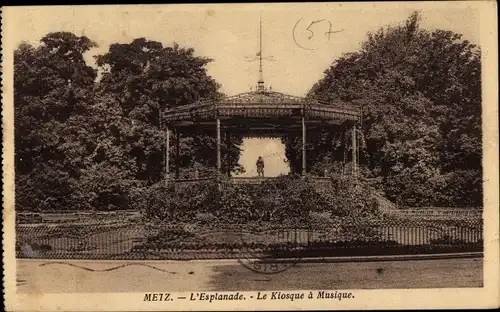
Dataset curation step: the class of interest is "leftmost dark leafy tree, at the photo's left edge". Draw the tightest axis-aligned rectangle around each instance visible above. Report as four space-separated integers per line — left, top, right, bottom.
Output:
14 32 97 210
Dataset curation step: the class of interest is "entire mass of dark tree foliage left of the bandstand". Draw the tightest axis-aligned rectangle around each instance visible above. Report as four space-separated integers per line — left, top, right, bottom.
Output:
14 32 241 211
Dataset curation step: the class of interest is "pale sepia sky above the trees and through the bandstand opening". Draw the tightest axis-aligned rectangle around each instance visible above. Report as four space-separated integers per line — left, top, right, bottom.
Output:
3 2 480 175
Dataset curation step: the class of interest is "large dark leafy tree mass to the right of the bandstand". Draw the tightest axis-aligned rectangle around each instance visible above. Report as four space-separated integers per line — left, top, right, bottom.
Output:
296 12 482 206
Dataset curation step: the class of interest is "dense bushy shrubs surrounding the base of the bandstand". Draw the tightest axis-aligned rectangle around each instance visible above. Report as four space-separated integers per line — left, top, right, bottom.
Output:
140 175 380 228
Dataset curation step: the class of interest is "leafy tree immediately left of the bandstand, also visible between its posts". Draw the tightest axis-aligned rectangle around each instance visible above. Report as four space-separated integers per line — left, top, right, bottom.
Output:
97 38 241 184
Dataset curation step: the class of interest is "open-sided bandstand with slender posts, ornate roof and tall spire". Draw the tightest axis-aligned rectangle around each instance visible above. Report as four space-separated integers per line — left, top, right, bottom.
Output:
165 18 362 182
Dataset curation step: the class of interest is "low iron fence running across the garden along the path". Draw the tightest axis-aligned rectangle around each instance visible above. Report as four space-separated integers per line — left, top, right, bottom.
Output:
16 219 483 260
